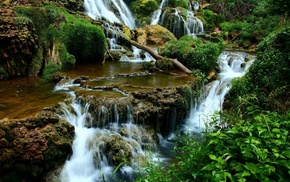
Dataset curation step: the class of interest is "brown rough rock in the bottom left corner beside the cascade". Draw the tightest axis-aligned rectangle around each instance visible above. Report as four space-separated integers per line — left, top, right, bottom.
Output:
0 111 74 181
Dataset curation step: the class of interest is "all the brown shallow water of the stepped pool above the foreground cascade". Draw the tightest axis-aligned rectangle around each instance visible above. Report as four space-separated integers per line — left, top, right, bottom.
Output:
0 62 194 120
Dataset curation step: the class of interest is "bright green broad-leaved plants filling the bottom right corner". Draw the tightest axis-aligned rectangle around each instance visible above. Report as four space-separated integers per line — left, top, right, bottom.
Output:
139 108 290 181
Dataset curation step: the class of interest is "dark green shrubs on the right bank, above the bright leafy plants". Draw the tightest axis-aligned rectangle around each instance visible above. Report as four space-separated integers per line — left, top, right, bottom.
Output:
226 26 290 113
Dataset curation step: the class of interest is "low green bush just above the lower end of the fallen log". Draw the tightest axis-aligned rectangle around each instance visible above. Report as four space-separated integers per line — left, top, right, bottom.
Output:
164 35 223 73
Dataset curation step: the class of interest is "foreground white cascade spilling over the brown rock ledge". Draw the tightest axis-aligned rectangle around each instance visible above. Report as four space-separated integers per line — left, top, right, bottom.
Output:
56 86 165 182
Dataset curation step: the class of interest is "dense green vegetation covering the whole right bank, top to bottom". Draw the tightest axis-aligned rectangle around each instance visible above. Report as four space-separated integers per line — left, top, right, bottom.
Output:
138 0 290 182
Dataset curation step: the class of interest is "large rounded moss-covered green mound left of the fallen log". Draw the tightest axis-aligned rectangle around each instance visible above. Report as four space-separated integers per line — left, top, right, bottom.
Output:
15 4 106 80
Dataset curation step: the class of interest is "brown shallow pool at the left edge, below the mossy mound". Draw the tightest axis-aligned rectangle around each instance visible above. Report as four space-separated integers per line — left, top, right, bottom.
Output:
0 77 66 120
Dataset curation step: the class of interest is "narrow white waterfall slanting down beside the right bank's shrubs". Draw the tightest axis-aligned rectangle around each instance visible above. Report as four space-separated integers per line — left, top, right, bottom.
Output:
183 52 255 133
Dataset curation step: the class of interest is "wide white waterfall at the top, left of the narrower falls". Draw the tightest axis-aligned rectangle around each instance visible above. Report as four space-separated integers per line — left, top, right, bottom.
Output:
84 0 136 29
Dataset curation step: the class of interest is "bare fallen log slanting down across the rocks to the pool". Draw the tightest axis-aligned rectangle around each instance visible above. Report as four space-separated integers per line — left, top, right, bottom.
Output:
129 40 191 74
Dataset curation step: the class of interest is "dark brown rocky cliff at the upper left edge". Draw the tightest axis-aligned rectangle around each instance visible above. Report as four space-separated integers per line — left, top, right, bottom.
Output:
0 6 38 80
